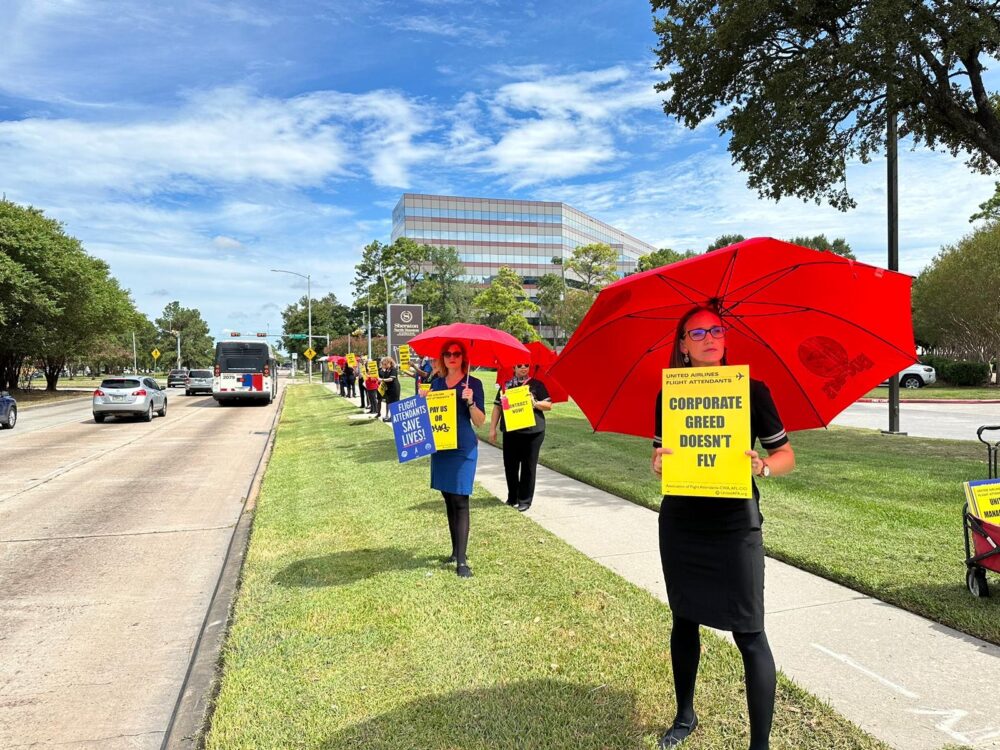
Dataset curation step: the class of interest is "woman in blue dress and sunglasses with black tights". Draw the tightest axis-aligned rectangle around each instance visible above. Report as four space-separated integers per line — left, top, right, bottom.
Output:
431 341 486 578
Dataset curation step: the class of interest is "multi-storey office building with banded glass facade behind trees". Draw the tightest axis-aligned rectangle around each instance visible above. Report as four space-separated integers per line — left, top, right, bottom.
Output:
392 193 656 296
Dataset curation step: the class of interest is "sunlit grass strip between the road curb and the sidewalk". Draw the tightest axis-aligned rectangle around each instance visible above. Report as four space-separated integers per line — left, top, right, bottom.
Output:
207 387 885 750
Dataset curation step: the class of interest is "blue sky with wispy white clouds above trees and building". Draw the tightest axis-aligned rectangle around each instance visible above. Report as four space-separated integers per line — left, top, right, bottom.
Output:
0 0 992 336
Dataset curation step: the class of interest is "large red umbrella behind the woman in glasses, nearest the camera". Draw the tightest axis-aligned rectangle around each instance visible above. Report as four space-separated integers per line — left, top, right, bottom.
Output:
552 237 916 437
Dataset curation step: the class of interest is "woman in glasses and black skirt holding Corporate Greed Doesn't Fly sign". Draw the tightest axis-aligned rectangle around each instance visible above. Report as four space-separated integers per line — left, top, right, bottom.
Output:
652 308 795 750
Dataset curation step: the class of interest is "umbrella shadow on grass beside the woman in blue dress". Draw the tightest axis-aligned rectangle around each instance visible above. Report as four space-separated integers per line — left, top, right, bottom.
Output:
274 547 437 586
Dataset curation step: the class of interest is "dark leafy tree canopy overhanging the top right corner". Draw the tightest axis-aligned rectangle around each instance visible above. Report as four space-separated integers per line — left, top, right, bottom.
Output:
652 0 1000 210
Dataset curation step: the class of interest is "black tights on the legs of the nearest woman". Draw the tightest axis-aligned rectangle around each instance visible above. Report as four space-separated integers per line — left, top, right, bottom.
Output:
670 615 776 750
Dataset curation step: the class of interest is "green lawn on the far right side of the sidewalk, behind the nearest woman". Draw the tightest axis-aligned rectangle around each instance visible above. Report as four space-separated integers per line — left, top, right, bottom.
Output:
480 388 1000 643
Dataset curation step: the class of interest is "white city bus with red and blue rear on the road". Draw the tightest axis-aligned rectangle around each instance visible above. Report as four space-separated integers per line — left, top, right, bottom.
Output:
212 339 278 405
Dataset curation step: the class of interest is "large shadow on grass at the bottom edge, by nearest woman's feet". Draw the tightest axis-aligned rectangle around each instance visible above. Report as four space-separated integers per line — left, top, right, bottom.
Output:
322 680 643 750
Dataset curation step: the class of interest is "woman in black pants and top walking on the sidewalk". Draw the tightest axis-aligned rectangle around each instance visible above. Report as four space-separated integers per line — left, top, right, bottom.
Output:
490 364 552 513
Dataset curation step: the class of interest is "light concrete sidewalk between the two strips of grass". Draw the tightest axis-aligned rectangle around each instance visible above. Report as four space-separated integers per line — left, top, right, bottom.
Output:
334 388 1000 750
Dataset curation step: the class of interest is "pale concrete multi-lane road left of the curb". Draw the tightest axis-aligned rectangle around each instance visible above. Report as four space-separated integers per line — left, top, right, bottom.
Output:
0 388 277 750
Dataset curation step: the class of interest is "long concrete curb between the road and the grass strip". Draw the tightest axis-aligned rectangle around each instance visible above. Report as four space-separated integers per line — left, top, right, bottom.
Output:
160 390 285 750
